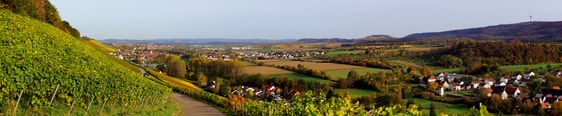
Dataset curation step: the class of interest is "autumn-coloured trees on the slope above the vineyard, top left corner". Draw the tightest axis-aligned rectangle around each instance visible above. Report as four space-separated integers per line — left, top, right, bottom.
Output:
0 0 80 38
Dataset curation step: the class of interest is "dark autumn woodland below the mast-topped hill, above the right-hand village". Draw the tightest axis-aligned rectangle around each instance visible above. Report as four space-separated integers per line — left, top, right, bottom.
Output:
425 41 562 68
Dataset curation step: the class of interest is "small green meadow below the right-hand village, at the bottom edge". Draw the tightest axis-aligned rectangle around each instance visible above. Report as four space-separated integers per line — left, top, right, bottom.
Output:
404 98 471 115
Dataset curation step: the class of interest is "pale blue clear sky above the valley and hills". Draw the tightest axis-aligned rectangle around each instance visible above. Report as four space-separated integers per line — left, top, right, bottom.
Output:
50 0 562 39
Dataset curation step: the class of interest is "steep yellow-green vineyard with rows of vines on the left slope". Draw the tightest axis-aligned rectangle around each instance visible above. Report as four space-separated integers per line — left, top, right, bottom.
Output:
0 10 171 115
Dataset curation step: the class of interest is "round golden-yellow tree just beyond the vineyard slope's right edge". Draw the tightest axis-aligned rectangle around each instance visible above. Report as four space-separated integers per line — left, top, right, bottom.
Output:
166 55 187 78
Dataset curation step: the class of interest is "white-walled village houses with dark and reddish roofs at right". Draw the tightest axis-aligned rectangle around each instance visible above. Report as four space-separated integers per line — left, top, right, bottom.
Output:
420 71 562 109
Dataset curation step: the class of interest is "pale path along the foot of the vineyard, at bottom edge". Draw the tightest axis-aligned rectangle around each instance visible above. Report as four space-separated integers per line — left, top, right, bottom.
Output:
172 92 225 116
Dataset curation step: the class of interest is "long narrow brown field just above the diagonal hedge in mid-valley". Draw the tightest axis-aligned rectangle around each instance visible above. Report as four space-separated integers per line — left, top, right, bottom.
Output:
258 60 365 71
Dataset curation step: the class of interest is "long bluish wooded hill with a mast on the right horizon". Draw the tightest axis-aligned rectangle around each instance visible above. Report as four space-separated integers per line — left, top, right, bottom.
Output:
404 21 562 42
